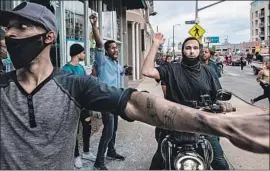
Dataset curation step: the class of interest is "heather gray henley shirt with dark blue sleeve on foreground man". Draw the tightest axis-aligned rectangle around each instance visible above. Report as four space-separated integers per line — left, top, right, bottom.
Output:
0 71 131 170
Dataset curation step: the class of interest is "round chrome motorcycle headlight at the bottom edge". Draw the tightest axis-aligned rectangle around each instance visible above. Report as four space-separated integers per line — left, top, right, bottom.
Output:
174 154 205 170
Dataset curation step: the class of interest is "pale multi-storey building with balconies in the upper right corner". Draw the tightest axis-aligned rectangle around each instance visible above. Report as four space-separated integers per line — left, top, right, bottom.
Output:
250 0 270 46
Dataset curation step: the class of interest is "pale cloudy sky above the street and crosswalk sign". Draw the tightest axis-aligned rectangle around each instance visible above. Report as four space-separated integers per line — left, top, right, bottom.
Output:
150 0 251 47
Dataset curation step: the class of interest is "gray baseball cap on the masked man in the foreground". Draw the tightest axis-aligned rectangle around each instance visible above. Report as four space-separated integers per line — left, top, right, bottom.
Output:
0 2 58 33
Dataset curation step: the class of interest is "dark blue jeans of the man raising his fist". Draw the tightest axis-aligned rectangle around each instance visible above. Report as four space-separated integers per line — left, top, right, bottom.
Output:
96 113 118 164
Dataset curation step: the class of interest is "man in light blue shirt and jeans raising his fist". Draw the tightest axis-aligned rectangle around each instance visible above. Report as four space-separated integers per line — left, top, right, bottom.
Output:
90 14 125 170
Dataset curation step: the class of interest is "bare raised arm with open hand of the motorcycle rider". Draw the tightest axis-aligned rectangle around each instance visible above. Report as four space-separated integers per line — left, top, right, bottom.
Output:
142 33 164 79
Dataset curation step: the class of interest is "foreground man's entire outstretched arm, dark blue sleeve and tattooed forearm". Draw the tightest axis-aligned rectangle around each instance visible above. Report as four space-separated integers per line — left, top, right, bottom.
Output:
81 75 270 153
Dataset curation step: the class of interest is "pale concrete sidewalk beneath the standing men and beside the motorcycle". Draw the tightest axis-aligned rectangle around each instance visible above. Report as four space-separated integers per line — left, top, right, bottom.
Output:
79 78 262 170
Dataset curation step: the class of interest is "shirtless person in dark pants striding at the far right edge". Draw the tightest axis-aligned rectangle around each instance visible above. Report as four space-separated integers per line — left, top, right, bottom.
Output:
250 61 270 104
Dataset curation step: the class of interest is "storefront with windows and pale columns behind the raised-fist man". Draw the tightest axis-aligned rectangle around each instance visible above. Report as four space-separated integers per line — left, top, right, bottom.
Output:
0 0 151 86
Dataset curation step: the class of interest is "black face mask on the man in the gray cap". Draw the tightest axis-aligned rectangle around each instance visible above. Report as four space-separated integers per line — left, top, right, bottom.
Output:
5 33 47 69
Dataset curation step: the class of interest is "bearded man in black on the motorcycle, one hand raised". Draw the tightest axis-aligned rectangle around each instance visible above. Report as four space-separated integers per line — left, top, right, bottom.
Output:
142 37 232 170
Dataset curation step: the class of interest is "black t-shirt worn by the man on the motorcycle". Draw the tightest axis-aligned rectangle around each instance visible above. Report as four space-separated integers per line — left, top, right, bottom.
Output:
157 63 221 105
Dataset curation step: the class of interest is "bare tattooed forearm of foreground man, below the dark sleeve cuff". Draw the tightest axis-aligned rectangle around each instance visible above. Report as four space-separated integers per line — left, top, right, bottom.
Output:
125 92 270 153
